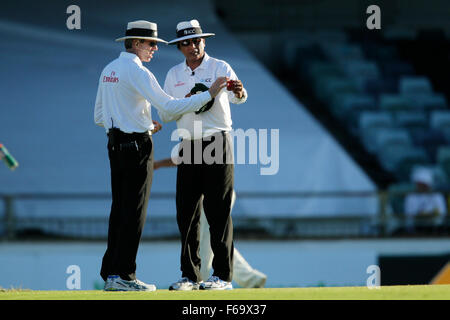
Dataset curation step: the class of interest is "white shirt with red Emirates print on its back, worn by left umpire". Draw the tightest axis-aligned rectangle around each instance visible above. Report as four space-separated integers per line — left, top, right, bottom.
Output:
94 52 211 133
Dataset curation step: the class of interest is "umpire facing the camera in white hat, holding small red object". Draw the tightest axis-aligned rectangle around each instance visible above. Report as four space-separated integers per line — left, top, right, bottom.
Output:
158 20 247 290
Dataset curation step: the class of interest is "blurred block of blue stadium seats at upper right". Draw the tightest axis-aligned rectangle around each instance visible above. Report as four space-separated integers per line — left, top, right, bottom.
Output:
280 28 450 201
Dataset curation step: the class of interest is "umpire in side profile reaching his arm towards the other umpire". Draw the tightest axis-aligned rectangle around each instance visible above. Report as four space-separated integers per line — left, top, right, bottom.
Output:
94 20 226 291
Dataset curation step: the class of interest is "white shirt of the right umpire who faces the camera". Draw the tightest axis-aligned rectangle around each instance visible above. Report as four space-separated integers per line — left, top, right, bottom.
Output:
158 53 247 140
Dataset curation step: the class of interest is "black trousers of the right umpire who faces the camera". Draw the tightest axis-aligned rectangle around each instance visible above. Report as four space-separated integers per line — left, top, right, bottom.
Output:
176 133 234 282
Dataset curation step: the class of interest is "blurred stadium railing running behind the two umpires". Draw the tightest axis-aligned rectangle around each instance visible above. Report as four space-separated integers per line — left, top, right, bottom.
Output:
0 190 450 241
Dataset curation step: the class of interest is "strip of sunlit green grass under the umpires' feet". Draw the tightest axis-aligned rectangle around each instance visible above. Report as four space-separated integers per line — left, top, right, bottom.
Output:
0 285 450 300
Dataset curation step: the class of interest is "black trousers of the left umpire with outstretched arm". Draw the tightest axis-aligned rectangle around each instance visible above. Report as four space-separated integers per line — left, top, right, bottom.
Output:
100 131 153 281
